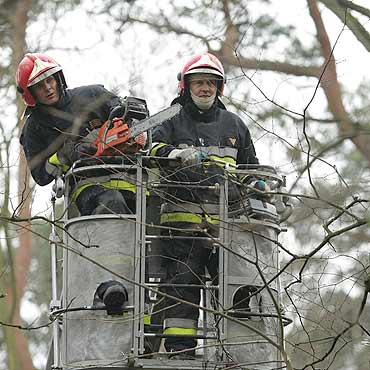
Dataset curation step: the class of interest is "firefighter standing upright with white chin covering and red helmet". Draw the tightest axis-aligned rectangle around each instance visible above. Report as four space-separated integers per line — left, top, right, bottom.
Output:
150 53 258 358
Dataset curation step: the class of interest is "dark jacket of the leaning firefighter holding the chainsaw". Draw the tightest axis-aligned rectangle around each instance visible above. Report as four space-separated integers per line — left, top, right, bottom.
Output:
20 85 120 186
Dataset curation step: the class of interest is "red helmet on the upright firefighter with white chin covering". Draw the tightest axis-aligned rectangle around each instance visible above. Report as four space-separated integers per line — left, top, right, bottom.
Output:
178 53 225 96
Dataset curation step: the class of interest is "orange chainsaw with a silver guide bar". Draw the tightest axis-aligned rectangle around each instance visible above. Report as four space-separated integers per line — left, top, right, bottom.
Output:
93 96 182 157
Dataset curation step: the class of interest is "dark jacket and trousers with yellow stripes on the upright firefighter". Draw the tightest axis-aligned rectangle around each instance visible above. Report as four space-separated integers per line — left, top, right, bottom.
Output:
150 100 258 338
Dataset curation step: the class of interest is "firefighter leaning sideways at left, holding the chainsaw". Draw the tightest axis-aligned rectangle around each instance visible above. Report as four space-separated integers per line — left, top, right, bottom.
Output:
16 53 143 215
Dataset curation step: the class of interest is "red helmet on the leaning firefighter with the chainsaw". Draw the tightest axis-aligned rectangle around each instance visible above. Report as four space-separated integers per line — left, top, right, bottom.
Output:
16 53 67 107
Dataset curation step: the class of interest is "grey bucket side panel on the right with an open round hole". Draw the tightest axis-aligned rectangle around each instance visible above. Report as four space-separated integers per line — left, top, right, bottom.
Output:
225 224 281 370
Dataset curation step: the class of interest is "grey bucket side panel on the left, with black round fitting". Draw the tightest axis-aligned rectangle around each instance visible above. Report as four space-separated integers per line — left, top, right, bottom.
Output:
63 217 135 367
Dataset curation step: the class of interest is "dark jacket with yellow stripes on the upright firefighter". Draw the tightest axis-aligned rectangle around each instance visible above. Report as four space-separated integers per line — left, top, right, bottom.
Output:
150 101 258 226
